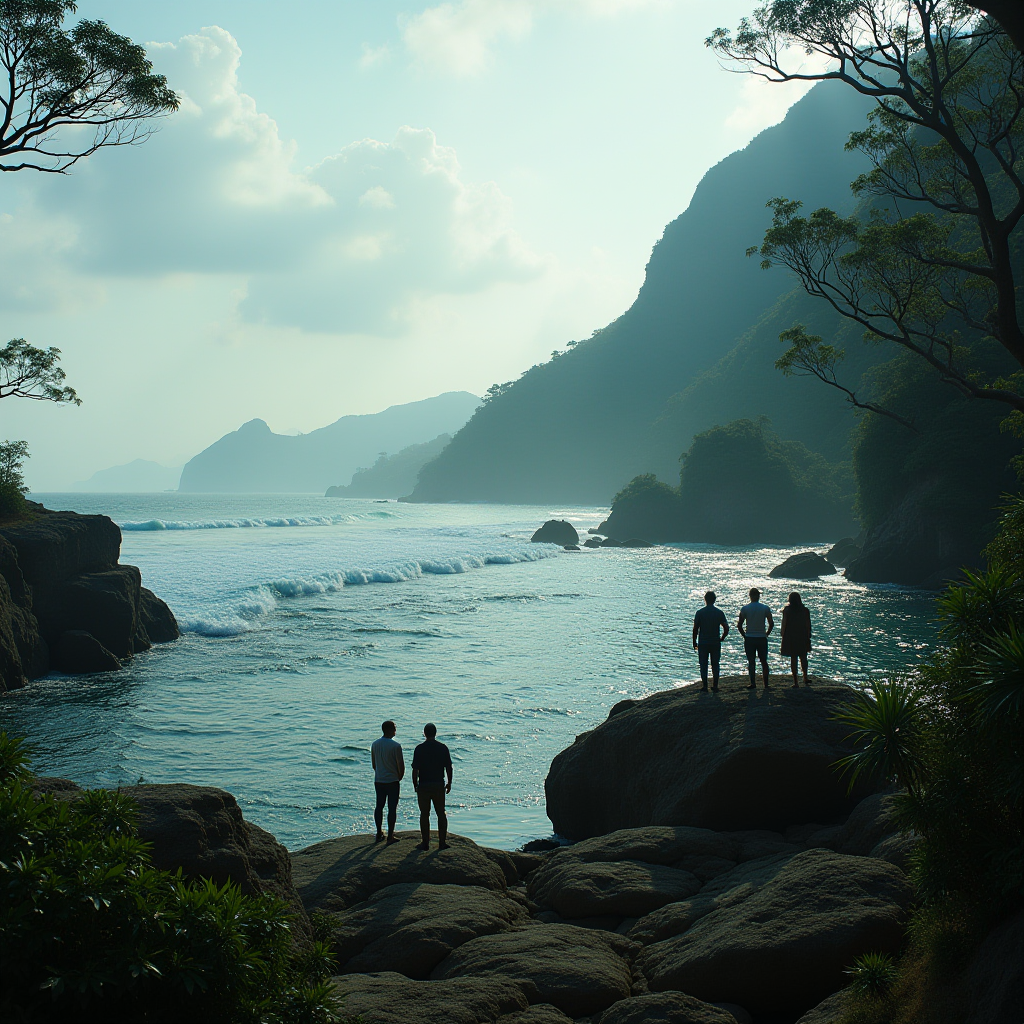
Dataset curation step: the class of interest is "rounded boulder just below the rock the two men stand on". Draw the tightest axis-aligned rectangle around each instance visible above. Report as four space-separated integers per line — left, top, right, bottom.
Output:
334 882 529 979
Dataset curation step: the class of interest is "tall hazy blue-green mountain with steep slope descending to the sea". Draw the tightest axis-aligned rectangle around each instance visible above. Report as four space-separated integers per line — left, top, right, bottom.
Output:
412 83 869 503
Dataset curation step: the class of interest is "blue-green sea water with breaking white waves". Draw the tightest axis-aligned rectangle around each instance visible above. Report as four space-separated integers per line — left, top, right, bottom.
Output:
0 493 935 849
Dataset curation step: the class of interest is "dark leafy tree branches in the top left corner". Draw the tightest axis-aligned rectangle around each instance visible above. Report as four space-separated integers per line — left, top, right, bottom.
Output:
0 0 178 174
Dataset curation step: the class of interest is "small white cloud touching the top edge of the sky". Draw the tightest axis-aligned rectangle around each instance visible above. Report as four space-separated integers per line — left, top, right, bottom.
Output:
399 0 663 78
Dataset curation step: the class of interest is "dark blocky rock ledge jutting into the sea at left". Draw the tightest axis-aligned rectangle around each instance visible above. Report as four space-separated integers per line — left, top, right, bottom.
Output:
0 503 178 692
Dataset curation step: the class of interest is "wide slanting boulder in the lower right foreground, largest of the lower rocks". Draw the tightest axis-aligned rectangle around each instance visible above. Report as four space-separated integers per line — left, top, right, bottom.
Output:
639 850 912 1018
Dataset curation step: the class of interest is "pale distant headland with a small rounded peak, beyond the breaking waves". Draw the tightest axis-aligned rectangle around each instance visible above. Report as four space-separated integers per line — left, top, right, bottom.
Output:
178 391 480 494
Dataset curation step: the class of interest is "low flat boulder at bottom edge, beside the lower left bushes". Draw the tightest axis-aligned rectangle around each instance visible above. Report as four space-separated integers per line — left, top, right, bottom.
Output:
332 972 527 1024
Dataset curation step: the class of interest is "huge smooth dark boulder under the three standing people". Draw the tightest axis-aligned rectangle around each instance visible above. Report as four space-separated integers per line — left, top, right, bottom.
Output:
545 677 866 840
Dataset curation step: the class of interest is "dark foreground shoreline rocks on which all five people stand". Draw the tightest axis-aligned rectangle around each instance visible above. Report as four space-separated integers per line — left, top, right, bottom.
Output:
25 677 1024 1024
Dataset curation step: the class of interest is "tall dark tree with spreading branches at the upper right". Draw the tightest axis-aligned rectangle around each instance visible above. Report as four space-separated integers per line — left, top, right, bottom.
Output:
707 0 1024 419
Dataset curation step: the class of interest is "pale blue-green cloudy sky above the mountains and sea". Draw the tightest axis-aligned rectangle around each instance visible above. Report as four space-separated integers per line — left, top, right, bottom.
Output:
0 0 805 490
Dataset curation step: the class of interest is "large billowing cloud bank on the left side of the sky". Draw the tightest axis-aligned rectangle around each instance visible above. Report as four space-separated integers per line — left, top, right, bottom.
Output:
0 28 544 334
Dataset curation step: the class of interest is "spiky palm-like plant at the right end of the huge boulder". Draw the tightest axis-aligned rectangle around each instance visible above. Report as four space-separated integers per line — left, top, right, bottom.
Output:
835 677 926 791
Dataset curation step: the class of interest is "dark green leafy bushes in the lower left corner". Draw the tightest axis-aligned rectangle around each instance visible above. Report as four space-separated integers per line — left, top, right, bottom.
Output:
0 732 344 1024
